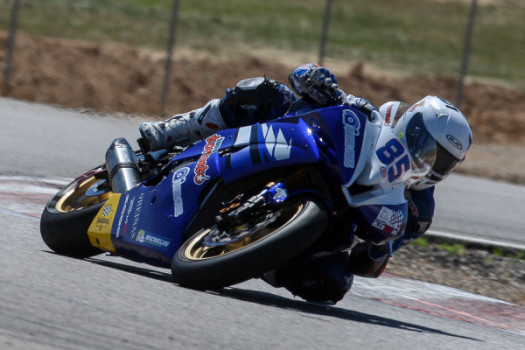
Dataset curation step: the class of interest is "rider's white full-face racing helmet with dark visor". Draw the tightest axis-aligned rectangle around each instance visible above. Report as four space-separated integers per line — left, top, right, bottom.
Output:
393 96 472 190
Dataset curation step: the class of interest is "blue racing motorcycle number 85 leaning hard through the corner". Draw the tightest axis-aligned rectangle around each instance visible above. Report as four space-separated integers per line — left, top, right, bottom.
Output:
41 105 412 289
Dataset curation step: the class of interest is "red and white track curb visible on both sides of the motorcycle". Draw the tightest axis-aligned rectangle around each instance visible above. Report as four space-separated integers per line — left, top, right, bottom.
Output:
0 175 525 334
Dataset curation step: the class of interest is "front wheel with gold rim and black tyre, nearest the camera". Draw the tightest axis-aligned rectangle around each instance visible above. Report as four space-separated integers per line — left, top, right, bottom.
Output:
171 195 328 289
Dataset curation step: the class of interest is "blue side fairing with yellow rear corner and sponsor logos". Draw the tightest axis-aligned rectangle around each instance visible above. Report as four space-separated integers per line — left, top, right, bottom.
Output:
88 106 406 266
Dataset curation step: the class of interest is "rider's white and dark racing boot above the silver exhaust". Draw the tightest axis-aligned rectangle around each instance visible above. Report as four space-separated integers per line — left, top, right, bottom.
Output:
139 99 227 151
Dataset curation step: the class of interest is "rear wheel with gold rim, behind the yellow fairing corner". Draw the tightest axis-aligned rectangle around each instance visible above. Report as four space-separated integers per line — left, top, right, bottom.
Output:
40 167 111 258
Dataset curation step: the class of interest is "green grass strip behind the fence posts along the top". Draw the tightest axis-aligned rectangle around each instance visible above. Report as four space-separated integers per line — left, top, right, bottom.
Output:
0 0 525 88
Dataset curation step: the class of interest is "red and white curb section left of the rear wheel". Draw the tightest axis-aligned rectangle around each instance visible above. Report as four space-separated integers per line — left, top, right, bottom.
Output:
0 175 71 219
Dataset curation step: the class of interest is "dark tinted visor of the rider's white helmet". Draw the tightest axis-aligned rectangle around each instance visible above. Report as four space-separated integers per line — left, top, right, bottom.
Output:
405 113 437 176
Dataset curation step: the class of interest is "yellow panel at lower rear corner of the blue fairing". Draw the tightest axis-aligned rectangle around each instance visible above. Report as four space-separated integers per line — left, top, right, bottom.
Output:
88 193 121 253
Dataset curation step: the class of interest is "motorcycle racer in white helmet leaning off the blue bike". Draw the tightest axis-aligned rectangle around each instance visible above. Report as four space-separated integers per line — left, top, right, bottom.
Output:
139 63 472 304
